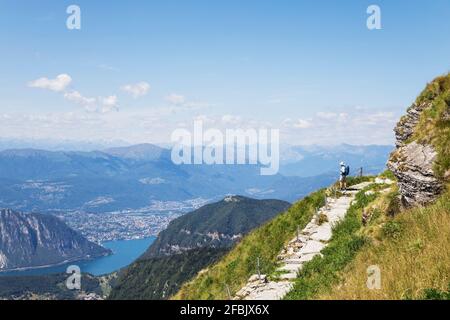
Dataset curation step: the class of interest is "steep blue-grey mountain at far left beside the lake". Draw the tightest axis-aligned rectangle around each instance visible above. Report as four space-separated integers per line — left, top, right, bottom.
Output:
0 210 110 271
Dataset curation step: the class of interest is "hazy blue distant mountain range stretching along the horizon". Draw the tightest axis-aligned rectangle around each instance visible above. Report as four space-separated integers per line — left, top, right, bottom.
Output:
0 144 391 212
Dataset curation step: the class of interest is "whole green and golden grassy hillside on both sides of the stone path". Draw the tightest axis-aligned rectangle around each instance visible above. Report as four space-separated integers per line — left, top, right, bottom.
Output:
175 175 450 299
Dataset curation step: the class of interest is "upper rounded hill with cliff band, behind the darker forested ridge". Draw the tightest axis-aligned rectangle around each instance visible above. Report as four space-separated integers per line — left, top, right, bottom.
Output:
142 196 290 259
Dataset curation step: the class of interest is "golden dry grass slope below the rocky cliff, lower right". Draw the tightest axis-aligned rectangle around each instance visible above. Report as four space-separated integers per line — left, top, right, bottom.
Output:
317 185 450 299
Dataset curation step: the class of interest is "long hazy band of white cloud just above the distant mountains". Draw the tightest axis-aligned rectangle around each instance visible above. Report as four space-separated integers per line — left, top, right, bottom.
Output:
0 105 399 145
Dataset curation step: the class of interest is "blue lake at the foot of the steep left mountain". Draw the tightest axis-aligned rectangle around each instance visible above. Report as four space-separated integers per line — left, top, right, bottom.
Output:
0 237 156 276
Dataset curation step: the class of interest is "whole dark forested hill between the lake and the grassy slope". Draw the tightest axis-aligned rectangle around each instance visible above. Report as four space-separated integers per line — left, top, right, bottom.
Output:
110 196 290 299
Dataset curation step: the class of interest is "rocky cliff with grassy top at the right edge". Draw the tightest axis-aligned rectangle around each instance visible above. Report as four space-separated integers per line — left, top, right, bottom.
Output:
388 75 450 206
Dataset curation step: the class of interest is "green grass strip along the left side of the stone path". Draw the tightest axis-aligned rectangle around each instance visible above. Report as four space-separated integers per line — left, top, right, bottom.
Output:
173 190 325 300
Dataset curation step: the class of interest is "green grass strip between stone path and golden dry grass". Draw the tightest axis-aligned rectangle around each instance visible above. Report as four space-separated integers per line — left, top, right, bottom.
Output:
285 189 377 300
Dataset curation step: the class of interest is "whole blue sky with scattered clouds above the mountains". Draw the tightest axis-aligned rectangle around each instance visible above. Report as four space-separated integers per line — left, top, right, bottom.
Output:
0 0 450 144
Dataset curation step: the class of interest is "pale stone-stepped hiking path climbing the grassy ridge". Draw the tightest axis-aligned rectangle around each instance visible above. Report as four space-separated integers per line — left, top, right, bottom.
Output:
234 182 371 300
